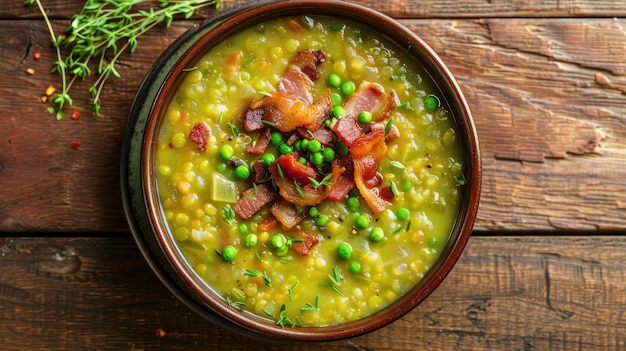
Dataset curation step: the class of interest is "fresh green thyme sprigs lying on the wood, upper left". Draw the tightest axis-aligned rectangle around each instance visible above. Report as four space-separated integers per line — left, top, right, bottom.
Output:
24 0 221 119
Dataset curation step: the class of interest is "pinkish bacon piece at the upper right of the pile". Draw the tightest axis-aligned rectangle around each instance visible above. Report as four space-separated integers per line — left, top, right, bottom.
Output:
343 81 398 122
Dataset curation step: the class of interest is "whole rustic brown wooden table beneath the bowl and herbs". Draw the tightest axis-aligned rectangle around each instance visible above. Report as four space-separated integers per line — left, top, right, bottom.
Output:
0 0 626 351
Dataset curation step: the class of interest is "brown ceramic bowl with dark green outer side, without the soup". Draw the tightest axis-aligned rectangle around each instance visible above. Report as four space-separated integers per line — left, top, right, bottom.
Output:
121 1 481 341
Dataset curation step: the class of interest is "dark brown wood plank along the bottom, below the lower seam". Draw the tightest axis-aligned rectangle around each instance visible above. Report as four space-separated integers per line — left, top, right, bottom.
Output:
0 235 626 351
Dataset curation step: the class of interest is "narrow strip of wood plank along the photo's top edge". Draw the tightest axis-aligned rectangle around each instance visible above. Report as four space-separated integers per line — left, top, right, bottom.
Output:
7 0 626 18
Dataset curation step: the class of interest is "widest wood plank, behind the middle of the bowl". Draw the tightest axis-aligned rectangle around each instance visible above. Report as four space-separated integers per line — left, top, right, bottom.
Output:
0 19 626 231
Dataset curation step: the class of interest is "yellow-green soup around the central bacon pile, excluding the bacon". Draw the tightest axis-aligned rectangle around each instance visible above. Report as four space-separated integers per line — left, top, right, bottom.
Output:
155 16 463 327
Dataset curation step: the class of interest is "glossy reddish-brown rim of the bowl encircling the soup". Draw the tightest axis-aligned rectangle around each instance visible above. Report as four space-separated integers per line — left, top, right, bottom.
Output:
131 1 481 341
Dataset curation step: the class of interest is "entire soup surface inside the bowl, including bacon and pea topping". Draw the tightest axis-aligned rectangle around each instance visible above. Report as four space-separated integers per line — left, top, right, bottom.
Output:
155 16 464 327
